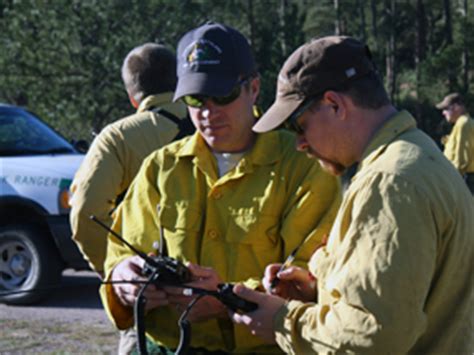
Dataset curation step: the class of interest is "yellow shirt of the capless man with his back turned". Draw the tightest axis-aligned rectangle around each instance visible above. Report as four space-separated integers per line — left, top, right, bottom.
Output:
70 92 186 272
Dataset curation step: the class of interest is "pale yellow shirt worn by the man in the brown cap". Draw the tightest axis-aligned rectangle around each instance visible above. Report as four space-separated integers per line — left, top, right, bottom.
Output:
274 111 474 354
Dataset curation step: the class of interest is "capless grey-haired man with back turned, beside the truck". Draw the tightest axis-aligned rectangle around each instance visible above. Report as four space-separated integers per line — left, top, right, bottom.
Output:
70 43 192 354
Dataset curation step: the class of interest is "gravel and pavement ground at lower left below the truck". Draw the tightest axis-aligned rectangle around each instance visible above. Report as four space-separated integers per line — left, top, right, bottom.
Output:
0 271 119 355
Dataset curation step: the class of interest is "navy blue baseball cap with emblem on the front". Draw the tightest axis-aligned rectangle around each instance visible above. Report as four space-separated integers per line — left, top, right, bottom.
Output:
173 22 257 101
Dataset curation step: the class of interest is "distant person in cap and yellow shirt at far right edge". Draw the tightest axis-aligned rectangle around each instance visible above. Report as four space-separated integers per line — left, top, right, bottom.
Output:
436 93 474 194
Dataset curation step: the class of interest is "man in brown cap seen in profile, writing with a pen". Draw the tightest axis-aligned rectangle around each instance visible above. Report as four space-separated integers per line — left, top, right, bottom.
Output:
233 36 474 354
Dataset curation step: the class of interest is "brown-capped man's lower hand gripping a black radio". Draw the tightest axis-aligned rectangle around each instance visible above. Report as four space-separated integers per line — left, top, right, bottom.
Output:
232 285 286 344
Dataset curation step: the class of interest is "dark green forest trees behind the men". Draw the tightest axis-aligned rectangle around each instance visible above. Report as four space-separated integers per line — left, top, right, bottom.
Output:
0 0 474 140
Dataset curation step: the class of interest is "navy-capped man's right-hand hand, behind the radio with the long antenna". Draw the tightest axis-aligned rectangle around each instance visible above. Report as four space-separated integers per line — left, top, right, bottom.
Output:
165 263 227 322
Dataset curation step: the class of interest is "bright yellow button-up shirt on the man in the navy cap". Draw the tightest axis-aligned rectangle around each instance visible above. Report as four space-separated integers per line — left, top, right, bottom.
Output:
101 131 340 353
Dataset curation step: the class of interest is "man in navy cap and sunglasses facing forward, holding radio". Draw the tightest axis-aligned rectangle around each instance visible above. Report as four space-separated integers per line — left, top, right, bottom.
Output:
101 23 340 353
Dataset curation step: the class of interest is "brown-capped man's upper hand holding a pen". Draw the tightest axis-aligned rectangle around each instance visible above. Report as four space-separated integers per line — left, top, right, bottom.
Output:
262 264 316 302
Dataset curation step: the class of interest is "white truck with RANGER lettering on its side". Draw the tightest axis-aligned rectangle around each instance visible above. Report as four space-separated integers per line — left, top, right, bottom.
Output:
0 104 87 304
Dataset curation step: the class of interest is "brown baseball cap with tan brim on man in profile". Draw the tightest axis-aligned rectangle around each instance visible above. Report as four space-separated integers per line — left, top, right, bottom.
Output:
252 36 375 132
